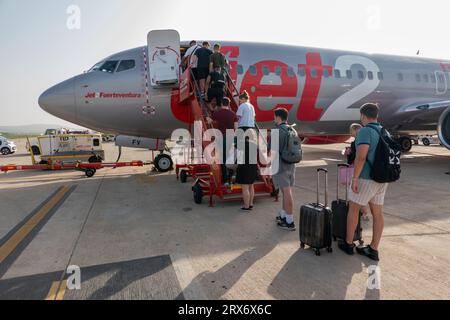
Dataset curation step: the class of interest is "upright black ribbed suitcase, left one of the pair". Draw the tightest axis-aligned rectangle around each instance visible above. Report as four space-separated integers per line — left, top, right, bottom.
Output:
299 168 333 256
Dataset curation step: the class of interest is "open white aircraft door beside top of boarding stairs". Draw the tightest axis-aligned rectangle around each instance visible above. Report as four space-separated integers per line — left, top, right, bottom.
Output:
147 30 181 87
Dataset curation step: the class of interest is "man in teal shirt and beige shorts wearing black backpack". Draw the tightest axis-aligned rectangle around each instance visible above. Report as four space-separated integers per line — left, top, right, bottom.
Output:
339 103 400 261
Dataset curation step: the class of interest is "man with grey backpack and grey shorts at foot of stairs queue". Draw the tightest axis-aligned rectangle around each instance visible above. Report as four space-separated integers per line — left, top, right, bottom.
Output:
272 108 302 231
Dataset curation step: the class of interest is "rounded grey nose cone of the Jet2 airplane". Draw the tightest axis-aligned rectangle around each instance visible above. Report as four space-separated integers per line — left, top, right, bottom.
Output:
39 78 76 122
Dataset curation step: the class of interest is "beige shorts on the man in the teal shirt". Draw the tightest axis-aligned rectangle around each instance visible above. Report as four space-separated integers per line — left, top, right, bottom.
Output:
348 179 388 206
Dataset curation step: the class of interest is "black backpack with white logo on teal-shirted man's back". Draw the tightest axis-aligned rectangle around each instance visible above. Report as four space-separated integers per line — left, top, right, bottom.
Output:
366 125 402 183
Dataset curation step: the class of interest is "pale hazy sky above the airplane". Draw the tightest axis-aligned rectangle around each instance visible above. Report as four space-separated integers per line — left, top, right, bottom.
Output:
0 0 450 126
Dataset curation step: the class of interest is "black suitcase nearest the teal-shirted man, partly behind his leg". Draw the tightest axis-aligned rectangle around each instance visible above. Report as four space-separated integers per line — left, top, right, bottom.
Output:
331 164 364 245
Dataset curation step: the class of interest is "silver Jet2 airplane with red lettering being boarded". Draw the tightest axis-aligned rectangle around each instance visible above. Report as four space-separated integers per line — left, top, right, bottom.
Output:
39 30 450 171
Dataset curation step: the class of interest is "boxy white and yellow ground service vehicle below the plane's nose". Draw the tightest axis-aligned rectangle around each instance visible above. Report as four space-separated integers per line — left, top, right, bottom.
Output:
29 134 105 164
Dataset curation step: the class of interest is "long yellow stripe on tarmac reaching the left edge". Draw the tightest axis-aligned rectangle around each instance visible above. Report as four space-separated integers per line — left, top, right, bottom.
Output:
0 186 70 263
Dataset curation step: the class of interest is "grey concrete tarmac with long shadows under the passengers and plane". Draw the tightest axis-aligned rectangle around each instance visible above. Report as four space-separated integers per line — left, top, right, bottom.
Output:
0 140 450 300
